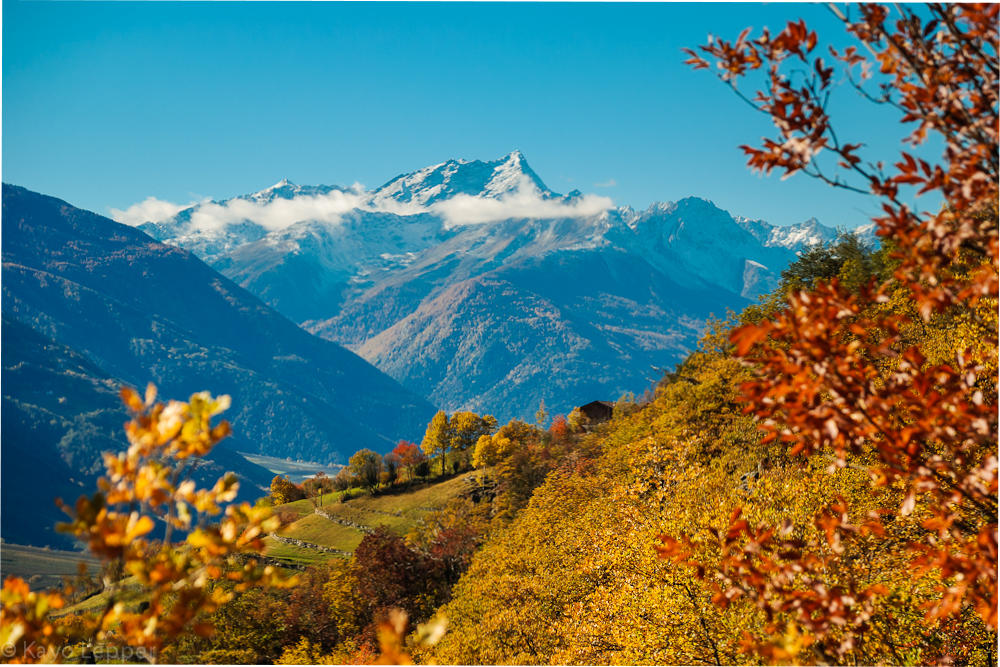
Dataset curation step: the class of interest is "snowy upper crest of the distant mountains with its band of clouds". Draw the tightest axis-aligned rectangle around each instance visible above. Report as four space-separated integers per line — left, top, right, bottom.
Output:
133 150 876 251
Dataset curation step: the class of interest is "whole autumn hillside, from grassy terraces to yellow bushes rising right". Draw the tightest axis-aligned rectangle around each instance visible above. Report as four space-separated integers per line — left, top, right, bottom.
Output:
15 219 996 664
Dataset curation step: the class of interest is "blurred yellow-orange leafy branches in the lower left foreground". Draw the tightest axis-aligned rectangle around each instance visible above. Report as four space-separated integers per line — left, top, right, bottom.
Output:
0 385 290 662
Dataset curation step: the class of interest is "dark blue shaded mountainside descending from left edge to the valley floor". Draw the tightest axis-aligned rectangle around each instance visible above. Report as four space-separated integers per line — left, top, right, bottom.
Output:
2 185 434 478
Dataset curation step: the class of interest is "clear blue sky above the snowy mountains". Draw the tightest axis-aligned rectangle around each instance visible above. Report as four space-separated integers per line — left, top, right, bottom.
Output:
2 0 932 227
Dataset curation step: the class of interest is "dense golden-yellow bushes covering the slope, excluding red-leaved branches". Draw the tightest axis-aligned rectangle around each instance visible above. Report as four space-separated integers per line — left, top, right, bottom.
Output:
426 349 995 664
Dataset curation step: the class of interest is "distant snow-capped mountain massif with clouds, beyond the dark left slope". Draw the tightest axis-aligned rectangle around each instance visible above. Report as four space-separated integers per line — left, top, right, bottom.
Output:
141 152 848 419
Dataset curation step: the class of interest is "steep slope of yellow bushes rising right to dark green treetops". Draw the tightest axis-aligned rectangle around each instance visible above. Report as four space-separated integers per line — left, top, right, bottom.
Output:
420 242 996 664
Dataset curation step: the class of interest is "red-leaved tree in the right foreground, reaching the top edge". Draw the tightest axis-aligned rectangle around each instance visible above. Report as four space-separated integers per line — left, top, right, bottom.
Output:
663 4 998 662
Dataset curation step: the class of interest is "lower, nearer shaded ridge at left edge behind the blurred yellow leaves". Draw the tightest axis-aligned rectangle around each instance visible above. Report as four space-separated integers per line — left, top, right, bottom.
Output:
0 311 271 547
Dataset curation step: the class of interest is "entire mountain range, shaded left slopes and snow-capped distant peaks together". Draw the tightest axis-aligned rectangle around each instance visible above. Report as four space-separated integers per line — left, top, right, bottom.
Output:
0 151 870 544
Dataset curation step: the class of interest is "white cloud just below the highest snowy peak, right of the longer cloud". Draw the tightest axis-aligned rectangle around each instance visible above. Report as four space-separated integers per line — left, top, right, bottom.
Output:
430 188 614 227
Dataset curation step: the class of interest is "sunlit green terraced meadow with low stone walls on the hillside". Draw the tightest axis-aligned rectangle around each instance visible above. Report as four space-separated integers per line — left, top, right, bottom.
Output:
264 472 477 564
